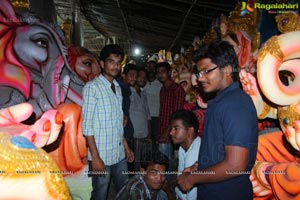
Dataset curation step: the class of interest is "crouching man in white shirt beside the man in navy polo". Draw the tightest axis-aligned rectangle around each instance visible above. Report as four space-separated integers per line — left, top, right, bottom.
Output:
170 110 201 200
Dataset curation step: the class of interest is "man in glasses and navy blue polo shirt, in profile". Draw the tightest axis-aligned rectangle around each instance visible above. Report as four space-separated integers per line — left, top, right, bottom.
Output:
177 41 258 200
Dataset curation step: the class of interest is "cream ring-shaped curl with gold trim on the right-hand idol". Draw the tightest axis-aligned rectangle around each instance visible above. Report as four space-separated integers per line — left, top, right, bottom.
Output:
257 31 300 106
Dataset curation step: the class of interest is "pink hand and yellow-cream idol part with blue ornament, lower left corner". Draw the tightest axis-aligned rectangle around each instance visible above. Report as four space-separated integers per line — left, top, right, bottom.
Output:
0 103 71 200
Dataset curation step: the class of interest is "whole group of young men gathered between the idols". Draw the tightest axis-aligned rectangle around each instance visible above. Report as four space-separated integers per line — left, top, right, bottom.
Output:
82 41 258 200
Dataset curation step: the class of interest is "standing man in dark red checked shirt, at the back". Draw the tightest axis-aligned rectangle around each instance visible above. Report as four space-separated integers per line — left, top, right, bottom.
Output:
156 62 186 181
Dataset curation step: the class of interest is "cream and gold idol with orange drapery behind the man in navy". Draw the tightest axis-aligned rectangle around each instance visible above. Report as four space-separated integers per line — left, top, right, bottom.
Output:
240 31 300 200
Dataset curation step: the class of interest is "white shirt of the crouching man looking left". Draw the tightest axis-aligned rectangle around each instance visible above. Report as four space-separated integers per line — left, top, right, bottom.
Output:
175 136 201 200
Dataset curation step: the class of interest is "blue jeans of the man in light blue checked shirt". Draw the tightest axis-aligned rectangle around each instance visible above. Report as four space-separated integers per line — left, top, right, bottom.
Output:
90 159 128 200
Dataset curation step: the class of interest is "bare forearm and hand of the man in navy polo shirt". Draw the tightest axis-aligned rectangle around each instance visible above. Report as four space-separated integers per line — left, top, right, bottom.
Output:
177 146 249 191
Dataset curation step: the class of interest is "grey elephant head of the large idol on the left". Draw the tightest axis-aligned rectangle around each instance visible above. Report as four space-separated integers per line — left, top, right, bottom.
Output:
0 0 70 118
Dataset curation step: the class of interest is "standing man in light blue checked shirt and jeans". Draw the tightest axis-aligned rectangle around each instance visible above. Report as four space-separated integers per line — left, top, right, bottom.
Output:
82 45 134 200
